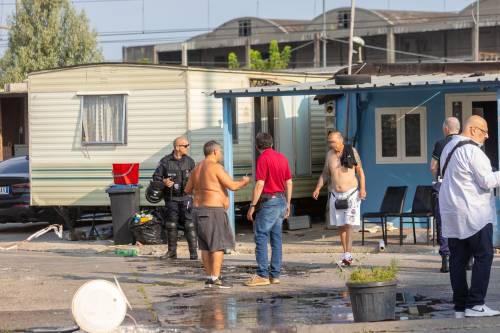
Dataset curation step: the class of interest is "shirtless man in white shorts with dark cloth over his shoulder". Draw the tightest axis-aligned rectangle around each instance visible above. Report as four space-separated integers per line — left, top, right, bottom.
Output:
312 131 366 266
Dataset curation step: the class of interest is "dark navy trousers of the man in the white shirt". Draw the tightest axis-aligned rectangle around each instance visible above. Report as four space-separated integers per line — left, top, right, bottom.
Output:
448 223 493 311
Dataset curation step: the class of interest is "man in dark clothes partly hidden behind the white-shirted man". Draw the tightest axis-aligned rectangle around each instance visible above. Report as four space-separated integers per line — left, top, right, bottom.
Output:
430 117 460 273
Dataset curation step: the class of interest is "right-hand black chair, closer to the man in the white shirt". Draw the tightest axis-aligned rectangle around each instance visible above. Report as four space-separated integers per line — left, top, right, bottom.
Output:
399 185 434 245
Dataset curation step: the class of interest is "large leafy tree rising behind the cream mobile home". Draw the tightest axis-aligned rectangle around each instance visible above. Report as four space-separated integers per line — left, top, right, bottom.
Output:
1 0 103 83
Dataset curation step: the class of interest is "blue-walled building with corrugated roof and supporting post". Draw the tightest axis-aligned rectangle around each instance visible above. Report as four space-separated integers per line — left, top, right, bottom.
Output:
214 65 500 244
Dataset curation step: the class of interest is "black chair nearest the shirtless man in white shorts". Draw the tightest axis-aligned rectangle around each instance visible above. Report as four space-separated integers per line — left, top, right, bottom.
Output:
361 186 408 245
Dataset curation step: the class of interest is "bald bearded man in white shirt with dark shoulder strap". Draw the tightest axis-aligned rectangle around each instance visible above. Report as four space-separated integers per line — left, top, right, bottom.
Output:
439 116 500 318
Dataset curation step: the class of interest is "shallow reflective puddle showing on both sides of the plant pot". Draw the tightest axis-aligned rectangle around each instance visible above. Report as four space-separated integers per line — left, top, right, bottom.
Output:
154 289 453 329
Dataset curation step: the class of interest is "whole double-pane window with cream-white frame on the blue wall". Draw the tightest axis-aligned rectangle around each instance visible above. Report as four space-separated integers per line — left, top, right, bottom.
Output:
375 108 427 164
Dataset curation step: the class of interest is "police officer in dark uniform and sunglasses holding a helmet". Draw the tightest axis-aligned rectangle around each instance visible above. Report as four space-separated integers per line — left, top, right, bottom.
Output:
153 136 198 260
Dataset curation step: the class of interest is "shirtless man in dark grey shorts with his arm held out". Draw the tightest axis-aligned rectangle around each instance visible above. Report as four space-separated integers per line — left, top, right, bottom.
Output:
185 141 250 288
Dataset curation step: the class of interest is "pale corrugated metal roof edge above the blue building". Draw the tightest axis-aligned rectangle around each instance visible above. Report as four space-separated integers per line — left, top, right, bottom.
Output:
212 73 500 97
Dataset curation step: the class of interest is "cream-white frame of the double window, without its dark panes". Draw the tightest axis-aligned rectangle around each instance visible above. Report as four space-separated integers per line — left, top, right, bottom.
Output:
375 107 427 164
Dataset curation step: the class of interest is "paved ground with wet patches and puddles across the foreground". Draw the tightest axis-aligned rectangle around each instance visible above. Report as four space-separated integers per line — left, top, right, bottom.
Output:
0 222 500 332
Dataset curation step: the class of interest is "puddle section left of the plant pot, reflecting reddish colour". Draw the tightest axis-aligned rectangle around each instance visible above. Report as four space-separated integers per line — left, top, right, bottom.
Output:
155 290 352 329
